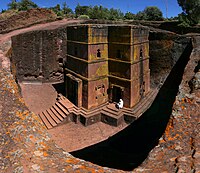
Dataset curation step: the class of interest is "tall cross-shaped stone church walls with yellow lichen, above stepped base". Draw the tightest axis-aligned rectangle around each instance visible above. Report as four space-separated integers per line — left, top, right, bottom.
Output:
64 24 150 110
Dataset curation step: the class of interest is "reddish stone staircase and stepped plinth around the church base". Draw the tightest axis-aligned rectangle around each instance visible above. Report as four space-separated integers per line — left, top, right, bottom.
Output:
38 89 158 129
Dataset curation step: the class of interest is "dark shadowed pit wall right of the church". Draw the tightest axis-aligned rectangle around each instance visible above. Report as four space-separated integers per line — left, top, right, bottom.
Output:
149 28 190 88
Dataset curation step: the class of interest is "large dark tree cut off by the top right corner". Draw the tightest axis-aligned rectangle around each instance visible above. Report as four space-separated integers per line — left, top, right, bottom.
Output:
177 0 200 25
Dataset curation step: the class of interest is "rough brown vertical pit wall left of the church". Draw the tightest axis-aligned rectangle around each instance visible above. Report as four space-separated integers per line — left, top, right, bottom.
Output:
12 28 67 82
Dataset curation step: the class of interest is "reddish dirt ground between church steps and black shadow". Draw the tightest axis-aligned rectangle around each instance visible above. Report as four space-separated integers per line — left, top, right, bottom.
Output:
48 122 127 152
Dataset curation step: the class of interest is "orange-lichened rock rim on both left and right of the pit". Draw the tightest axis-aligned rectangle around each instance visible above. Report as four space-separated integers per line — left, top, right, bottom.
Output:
0 12 200 173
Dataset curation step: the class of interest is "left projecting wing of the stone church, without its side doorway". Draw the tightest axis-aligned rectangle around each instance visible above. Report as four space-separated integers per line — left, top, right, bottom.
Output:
66 25 108 109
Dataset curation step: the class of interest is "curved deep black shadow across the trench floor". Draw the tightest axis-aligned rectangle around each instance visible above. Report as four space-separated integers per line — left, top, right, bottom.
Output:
71 43 192 171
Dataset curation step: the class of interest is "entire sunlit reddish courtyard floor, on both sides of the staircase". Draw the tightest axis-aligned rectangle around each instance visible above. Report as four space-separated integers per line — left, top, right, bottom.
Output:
20 83 127 152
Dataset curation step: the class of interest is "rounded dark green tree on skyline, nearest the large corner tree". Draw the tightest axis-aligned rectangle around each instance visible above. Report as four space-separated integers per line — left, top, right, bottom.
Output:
143 6 163 21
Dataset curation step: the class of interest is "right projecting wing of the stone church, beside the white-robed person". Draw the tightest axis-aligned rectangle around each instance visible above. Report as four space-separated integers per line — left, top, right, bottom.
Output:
108 25 150 107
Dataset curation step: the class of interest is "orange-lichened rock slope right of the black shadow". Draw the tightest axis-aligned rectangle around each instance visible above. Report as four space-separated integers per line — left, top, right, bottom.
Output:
136 36 200 173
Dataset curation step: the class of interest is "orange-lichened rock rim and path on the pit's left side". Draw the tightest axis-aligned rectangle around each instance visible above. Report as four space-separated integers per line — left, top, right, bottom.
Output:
0 16 122 173
